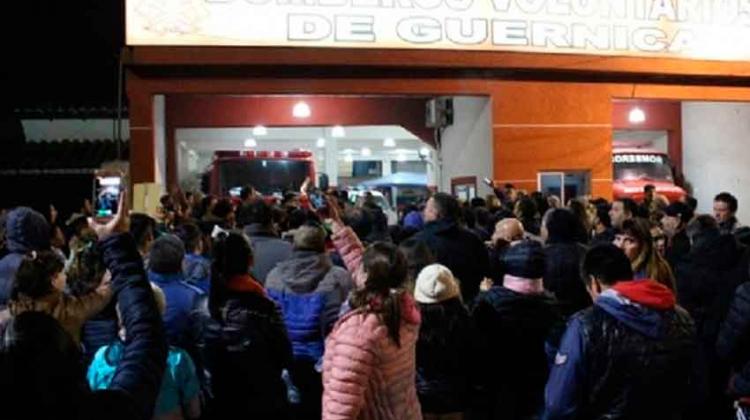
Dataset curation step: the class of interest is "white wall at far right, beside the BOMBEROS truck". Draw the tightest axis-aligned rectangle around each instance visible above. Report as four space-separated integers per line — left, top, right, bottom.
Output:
682 102 750 223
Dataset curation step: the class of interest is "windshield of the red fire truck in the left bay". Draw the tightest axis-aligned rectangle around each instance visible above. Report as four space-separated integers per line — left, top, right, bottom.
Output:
219 159 310 195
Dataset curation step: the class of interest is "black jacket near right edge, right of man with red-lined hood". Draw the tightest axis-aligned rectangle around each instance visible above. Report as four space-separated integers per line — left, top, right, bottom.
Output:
675 235 749 418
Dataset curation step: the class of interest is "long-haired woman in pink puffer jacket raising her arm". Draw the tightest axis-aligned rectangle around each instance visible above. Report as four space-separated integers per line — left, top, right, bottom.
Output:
322 196 422 419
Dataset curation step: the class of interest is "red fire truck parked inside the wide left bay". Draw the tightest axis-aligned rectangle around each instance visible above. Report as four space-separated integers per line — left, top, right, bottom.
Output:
202 150 315 197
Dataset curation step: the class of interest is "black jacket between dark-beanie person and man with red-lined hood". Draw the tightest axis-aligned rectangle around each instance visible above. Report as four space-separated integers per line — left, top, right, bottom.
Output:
544 242 591 318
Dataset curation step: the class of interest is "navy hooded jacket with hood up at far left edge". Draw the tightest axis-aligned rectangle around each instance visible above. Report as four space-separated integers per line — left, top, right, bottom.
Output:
0 207 50 308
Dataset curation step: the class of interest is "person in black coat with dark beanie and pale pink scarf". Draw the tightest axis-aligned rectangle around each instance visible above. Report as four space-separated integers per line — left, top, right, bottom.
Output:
472 240 564 420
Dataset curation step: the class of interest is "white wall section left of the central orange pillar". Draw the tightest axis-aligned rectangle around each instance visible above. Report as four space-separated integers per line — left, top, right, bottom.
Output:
439 96 493 197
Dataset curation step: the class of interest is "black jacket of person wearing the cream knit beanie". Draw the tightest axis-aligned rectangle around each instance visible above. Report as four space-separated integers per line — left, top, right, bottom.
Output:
417 298 480 414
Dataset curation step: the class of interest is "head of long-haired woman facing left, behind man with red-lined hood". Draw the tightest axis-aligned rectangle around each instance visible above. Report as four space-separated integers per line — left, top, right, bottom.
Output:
613 218 675 290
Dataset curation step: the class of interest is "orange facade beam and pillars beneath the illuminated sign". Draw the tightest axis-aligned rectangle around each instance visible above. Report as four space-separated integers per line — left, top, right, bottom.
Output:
128 47 750 198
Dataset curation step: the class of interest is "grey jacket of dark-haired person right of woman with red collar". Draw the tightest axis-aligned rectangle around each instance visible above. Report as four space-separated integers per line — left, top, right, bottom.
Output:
243 223 292 284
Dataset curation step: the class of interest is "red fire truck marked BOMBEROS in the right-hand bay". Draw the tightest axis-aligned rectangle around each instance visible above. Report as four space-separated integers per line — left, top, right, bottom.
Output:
612 145 685 202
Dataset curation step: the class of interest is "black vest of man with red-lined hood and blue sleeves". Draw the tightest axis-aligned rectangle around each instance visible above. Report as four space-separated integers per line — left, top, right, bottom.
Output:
575 305 694 420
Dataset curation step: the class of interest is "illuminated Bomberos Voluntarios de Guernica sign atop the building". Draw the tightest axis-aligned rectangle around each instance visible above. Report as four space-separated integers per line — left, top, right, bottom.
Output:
126 0 750 61
